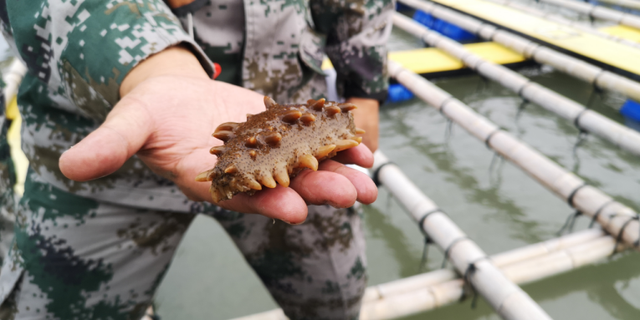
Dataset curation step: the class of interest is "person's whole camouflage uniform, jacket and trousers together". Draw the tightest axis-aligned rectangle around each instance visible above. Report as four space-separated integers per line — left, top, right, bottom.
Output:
0 0 393 319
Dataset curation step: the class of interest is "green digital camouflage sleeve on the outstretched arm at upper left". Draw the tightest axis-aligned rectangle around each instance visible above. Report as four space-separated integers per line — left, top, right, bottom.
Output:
0 0 213 111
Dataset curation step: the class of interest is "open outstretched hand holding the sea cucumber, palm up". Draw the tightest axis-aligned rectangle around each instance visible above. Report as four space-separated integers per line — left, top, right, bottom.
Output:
59 47 377 224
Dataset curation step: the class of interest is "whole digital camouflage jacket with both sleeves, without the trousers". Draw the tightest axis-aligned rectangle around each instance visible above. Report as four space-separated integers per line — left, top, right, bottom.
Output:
0 0 393 211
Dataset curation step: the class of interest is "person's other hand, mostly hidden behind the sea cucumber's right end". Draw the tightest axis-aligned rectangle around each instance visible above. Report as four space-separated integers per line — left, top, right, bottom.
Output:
346 98 380 152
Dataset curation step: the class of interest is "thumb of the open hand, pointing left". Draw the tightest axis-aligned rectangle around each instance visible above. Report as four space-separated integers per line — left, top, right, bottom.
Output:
59 97 152 181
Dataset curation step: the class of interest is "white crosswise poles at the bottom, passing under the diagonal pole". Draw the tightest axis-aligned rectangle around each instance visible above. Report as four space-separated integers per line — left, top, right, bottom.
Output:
228 195 615 320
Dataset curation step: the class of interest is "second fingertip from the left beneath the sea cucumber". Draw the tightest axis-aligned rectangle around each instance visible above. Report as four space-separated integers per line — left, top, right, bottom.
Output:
289 170 358 208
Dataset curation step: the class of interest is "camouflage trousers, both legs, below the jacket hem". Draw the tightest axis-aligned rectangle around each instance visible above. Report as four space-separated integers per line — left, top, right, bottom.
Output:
0 175 366 320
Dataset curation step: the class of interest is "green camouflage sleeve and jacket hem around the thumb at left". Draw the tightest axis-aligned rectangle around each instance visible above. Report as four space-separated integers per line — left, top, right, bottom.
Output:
0 0 211 211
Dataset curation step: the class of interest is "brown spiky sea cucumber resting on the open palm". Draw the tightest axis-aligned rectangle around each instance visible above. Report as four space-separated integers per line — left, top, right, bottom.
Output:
196 96 364 203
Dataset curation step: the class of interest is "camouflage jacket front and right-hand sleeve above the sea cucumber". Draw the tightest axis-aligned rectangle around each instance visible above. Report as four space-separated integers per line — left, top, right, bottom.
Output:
180 0 393 103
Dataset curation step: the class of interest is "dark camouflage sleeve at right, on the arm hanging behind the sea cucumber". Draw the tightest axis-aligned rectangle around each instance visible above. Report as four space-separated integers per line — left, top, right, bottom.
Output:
310 0 394 101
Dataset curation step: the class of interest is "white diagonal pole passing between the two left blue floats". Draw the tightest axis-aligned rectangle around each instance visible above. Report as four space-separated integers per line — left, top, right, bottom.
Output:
393 13 640 156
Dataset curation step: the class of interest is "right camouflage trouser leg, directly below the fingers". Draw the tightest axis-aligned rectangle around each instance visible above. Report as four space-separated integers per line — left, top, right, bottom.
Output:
214 206 367 320
